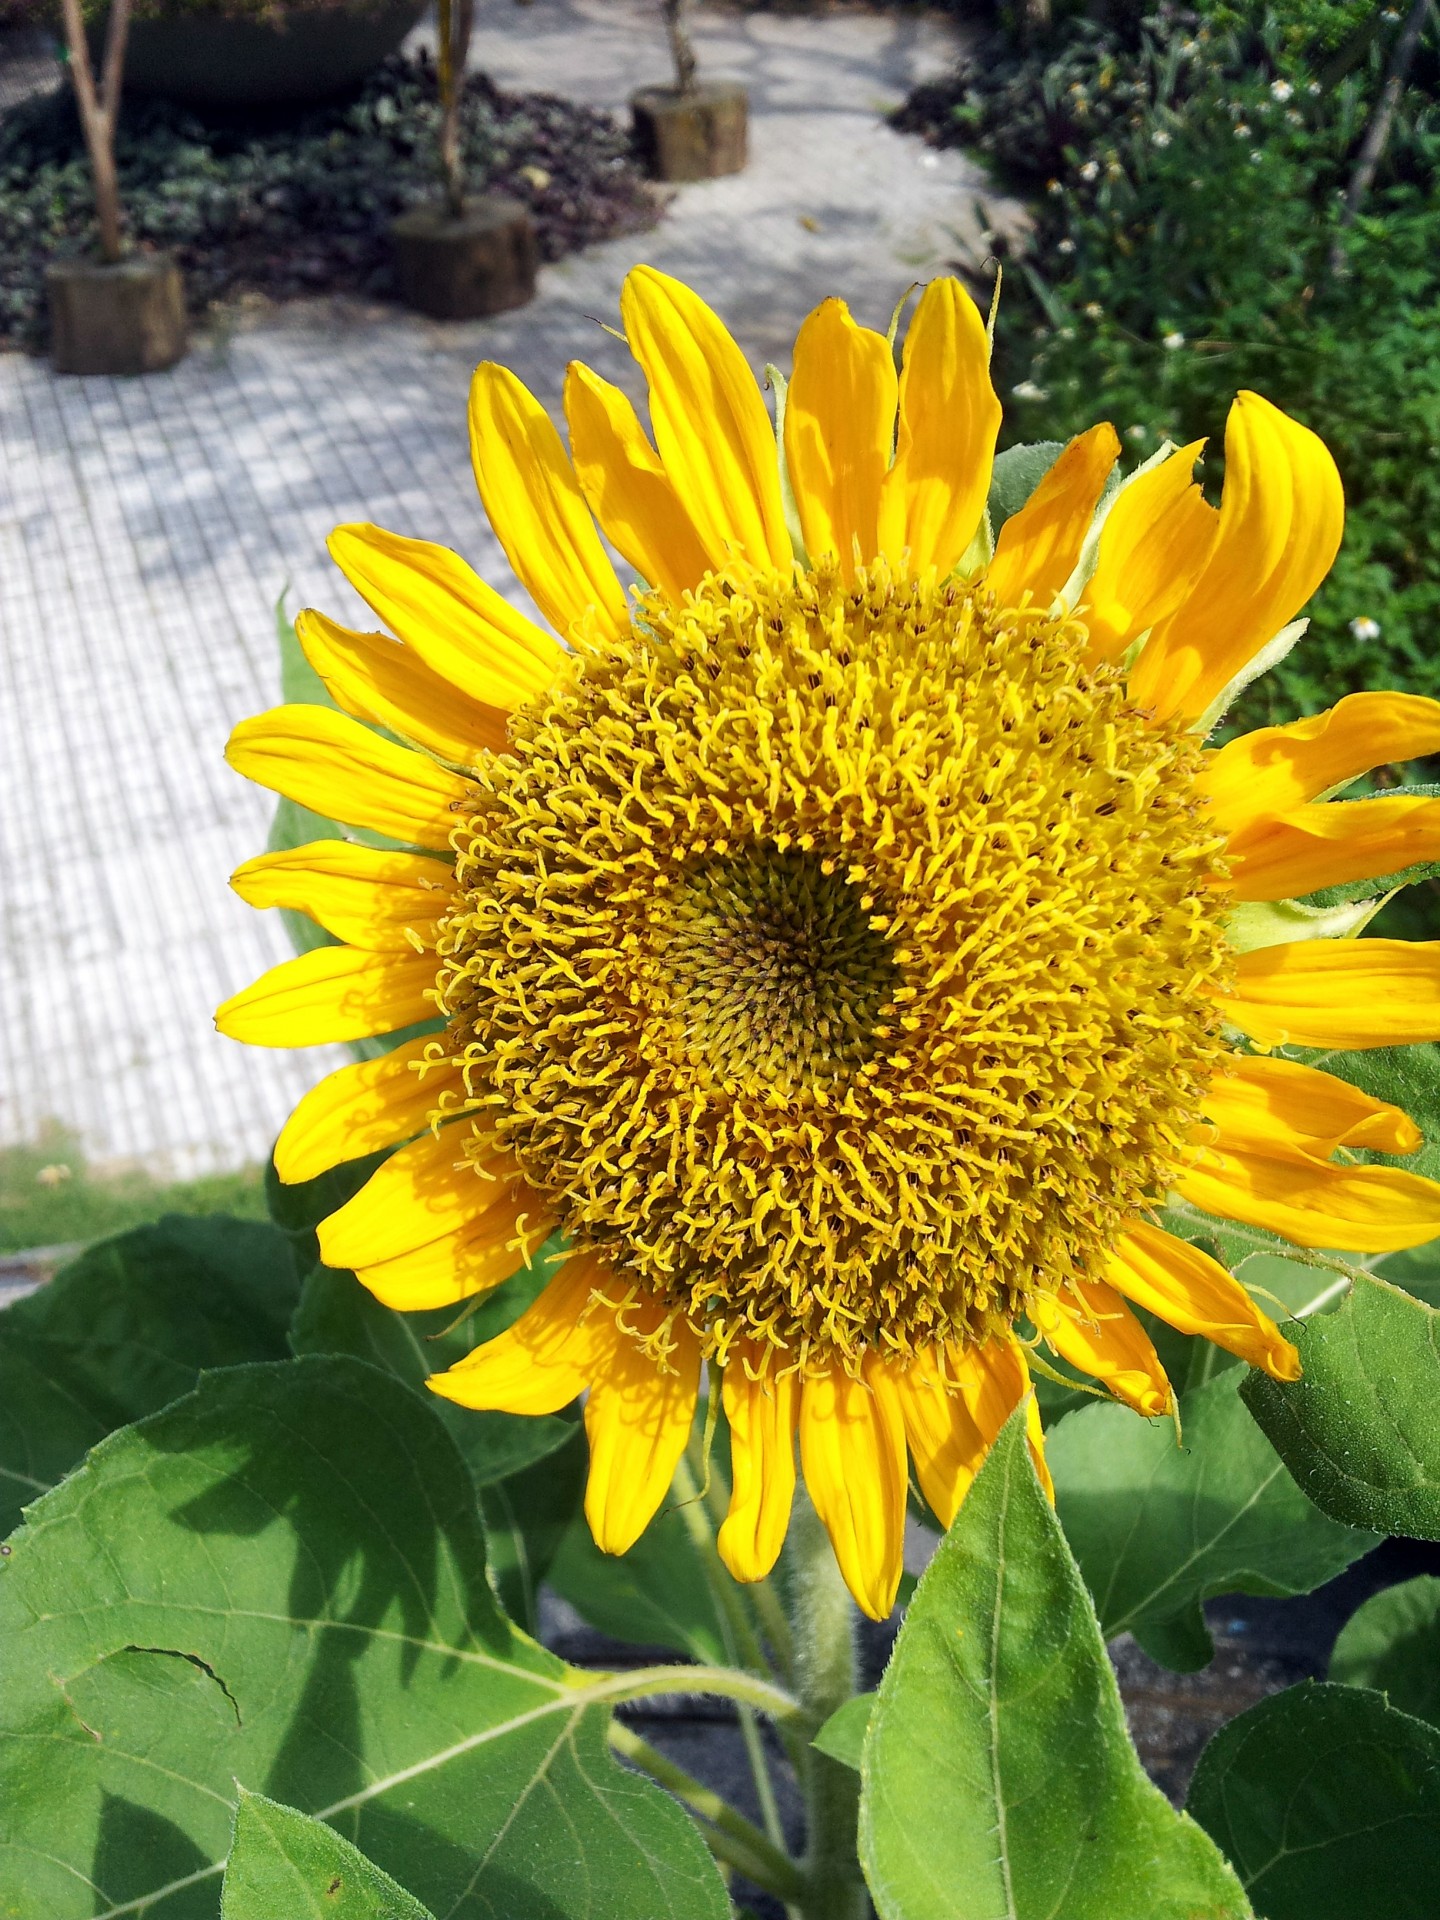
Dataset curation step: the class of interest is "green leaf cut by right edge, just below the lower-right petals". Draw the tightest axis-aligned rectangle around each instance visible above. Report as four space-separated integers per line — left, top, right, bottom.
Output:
1244 1275 1440 1540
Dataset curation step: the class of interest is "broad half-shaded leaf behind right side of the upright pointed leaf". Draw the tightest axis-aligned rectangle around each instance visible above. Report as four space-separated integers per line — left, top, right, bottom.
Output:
1046 1369 1375 1672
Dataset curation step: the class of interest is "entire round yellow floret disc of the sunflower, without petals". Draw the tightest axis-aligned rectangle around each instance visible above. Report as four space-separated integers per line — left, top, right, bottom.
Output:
440 566 1227 1367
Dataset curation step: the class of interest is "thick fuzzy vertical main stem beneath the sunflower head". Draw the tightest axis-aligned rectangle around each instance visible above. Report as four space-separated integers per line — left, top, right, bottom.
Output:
789 1492 866 1920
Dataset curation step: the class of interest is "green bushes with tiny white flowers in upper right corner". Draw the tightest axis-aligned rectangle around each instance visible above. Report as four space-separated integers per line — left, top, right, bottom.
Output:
900 0 1440 720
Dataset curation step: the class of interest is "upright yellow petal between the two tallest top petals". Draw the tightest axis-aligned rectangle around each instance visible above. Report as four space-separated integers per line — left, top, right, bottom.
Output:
785 300 899 582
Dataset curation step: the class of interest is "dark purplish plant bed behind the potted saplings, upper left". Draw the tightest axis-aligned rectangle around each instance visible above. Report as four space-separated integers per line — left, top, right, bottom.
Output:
0 56 657 349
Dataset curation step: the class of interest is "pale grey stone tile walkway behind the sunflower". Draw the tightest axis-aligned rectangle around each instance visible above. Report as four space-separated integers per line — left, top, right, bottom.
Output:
0 0 1013 1175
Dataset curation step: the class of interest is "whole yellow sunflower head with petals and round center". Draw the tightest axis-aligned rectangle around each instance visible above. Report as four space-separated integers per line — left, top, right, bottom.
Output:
219 267 1440 1617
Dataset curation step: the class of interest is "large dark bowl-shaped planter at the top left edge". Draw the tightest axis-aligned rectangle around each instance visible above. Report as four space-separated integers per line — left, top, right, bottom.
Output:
92 0 424 108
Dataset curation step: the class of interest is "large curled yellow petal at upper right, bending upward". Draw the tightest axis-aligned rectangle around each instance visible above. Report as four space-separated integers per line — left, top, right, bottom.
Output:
1131 394 1344 720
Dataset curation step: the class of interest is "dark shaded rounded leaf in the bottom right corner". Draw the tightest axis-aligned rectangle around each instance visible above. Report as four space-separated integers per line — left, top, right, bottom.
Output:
1188 1680 1440 1920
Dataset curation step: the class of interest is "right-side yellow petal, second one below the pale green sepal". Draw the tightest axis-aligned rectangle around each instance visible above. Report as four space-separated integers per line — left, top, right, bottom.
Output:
1204 1054 1425 1160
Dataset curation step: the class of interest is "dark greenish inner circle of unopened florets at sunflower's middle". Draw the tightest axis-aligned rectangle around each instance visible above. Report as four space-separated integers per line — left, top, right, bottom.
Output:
657 847 900 1098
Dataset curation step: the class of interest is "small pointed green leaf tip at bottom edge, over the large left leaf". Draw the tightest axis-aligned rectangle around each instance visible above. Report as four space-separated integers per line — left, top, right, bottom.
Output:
221 1788 434 1920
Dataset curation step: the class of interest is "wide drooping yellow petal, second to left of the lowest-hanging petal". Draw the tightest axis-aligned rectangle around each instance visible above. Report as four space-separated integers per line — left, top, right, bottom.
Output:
586 1306 701 1553
